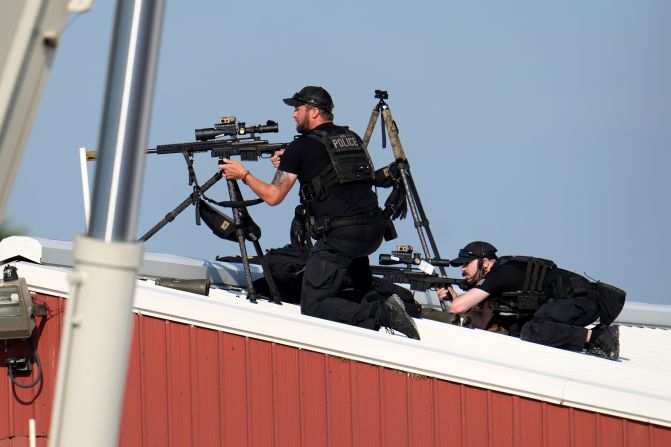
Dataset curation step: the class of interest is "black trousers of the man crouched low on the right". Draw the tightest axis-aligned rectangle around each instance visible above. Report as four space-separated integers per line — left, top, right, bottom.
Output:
520 296 599 351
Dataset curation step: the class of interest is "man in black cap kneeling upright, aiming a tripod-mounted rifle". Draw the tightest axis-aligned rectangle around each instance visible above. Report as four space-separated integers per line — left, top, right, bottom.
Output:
219 86 419 339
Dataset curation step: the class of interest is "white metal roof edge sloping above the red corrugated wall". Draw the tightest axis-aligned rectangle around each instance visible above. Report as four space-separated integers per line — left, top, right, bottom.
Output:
14 263 671 427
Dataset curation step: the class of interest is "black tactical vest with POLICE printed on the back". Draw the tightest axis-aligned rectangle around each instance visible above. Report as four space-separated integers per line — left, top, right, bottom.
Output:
300 126 375 203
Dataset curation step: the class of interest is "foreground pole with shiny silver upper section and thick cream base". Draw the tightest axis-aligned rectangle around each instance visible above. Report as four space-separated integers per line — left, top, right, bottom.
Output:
49 0 165 447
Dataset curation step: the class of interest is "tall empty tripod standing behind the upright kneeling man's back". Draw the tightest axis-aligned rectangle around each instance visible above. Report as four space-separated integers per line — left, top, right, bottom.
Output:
363 90 446 310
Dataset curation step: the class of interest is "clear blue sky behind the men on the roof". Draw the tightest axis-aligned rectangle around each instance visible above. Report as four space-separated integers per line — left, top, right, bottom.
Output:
7 0 671 304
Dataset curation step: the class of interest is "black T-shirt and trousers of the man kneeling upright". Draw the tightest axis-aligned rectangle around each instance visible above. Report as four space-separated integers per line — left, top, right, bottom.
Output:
279 123 384 330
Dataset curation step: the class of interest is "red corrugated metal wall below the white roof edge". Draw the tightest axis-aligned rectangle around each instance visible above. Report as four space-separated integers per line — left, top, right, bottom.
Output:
0 297 671 447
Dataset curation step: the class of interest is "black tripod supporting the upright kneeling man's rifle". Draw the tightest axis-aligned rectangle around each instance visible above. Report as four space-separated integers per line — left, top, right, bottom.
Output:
138 152 282 304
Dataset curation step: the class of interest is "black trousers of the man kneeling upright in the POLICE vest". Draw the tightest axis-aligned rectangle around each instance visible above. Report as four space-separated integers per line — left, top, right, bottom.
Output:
301 218 384 330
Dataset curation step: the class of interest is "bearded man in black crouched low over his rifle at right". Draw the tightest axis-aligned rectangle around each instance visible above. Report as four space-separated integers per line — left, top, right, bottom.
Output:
438 241 626 360
